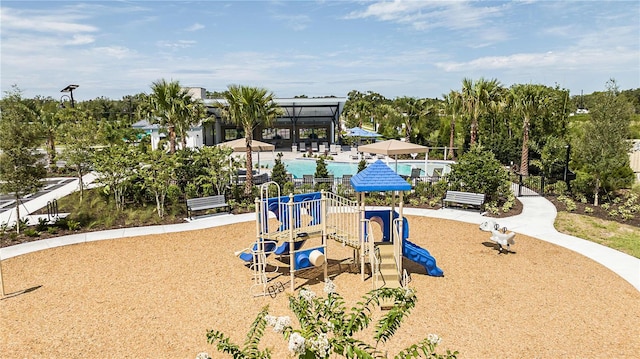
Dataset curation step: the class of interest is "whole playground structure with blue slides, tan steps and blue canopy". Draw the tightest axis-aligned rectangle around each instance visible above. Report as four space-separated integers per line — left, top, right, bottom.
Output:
236 161 443 296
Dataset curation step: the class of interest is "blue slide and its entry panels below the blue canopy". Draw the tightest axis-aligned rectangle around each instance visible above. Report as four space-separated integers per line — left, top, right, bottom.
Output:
364 210 444 277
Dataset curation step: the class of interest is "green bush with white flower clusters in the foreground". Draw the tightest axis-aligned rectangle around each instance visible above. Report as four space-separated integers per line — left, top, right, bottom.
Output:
202 281 458 359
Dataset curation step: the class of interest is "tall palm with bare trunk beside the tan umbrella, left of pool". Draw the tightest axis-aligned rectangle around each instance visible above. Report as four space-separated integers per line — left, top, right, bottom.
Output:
221 85 282 196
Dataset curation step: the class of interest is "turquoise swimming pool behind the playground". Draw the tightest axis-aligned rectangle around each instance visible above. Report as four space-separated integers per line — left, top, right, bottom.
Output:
264 158 453 178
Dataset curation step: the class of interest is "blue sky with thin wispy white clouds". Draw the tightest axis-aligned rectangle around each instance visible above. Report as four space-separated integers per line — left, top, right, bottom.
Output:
0 0 640 100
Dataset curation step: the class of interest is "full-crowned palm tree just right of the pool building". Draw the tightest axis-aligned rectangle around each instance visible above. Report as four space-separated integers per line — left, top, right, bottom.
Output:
462 77 500 145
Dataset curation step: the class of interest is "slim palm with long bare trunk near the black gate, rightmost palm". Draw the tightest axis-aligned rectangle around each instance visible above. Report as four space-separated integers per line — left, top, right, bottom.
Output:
511 84 545 176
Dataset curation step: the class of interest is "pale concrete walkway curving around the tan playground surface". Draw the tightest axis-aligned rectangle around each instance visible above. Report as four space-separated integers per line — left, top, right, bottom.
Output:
0 186 640 291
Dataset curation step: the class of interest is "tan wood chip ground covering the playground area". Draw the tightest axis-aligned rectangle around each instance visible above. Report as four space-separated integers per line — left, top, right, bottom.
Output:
0 216 640 358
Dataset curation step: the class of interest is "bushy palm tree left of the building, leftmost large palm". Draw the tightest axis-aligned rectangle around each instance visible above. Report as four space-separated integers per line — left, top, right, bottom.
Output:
150 79 192 153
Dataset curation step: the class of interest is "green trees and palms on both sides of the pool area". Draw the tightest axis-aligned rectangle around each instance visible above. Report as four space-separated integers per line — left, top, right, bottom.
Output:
0 78 640 233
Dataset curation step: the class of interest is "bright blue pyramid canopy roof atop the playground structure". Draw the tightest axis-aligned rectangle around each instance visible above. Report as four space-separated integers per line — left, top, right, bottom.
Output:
351 160 411 192
